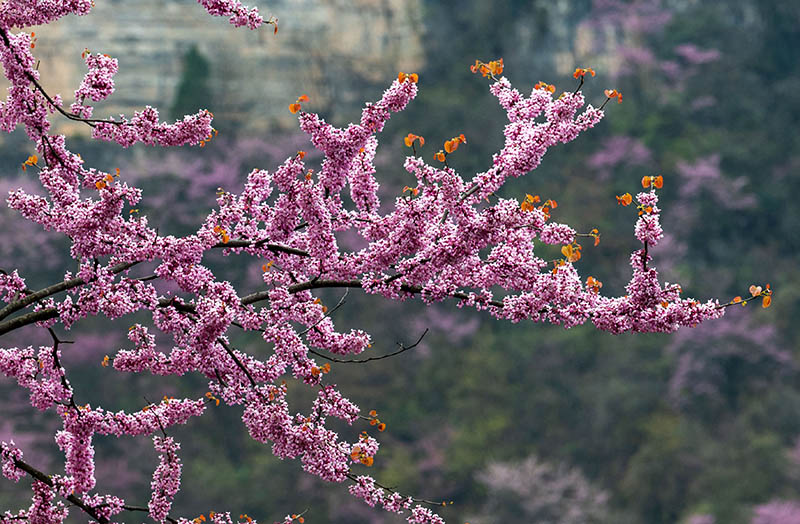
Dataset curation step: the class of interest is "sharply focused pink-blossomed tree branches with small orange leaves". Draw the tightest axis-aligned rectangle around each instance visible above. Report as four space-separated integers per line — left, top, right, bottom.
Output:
0 0 771 524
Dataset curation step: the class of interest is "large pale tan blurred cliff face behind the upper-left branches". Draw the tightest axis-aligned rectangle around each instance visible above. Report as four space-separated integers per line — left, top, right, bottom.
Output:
12 0 421 134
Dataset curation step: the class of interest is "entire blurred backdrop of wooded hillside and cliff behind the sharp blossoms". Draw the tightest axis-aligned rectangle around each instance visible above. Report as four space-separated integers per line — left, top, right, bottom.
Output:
0 0 800 524
